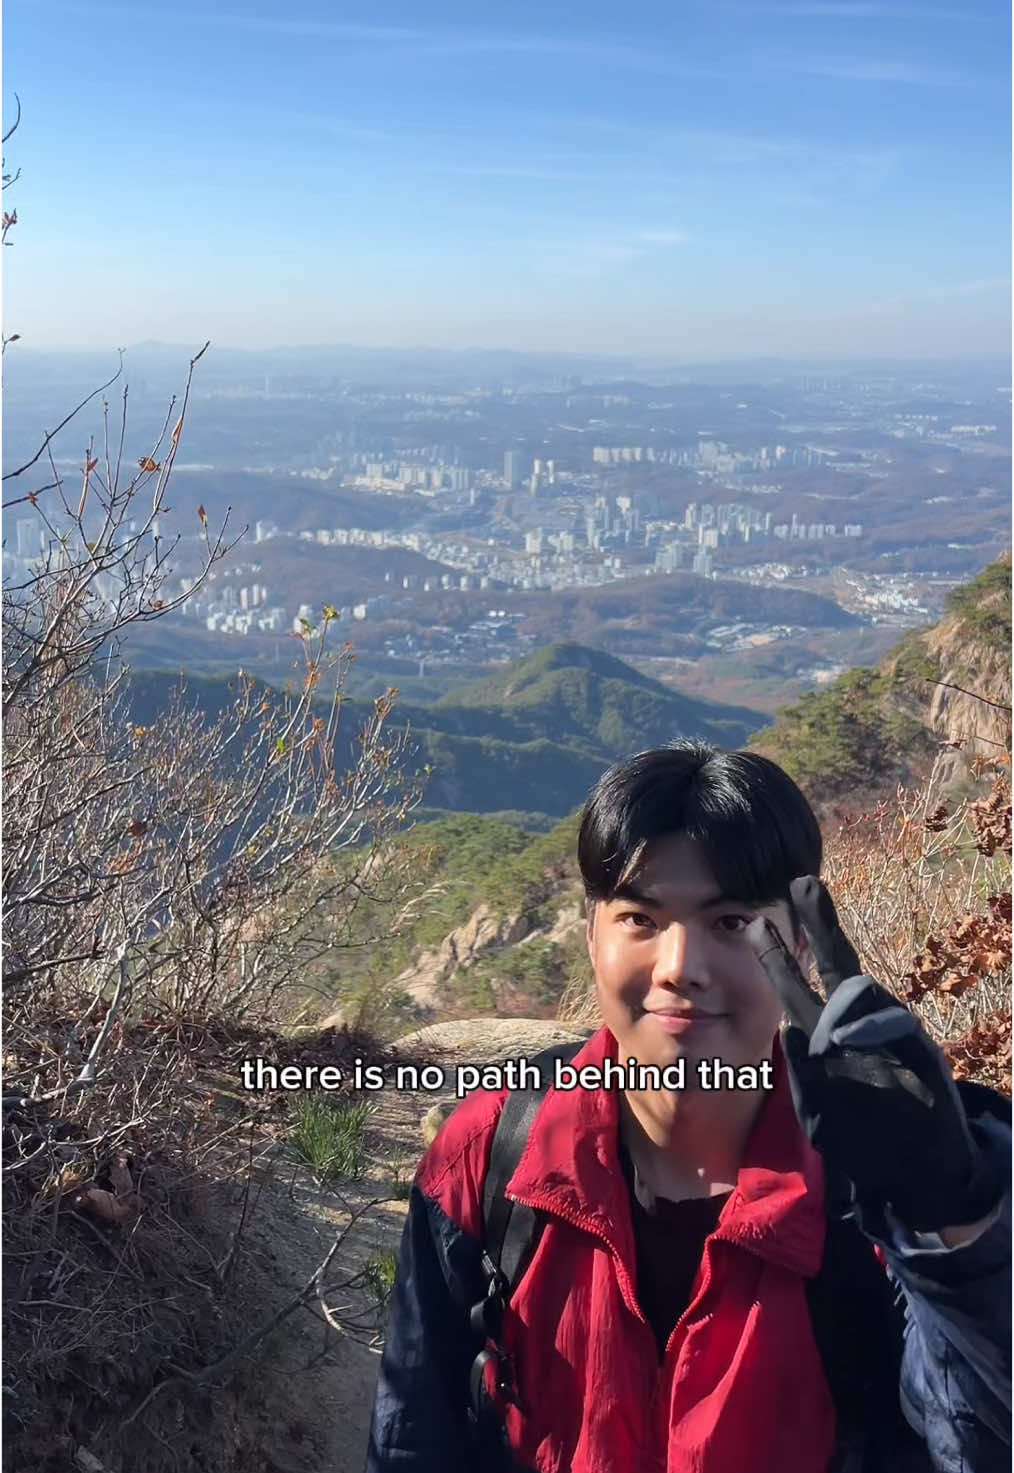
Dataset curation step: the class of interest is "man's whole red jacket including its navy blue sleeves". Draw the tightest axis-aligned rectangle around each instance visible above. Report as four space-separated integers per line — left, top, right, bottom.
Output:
366 1028 1011 1473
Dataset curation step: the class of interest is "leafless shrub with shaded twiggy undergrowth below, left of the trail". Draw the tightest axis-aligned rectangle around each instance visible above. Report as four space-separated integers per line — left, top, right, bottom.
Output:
1 349 419 1463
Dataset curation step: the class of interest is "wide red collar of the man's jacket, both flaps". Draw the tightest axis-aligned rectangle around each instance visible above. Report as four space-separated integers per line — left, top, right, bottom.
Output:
507 1028 827 1277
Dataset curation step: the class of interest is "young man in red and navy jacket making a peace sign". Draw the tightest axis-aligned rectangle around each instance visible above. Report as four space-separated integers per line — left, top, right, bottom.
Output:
367 742 1011 1473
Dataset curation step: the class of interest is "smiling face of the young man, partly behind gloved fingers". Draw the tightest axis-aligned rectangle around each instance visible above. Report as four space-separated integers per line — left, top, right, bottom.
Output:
588 835 808 1086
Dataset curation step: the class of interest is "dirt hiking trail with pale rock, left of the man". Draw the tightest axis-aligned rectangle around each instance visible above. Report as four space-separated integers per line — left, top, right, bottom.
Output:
191 1018 588 1473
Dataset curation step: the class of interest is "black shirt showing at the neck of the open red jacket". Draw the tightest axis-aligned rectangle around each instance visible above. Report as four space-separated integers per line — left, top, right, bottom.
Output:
619 1143 732 1360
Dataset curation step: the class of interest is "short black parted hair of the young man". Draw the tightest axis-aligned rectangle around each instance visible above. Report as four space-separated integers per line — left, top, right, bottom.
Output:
578 741 824 924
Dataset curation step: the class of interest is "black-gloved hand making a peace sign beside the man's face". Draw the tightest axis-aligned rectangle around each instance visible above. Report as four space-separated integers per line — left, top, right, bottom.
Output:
746 875 999 1230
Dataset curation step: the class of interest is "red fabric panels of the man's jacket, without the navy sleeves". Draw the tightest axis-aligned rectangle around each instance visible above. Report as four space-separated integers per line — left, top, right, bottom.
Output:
417 1028 836 1473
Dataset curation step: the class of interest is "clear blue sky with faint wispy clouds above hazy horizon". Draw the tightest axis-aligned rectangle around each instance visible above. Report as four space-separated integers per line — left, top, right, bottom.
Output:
3 0 1010 359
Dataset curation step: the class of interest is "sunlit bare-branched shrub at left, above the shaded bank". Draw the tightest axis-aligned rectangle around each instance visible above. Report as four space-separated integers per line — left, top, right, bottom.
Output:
3 355 416 1036
